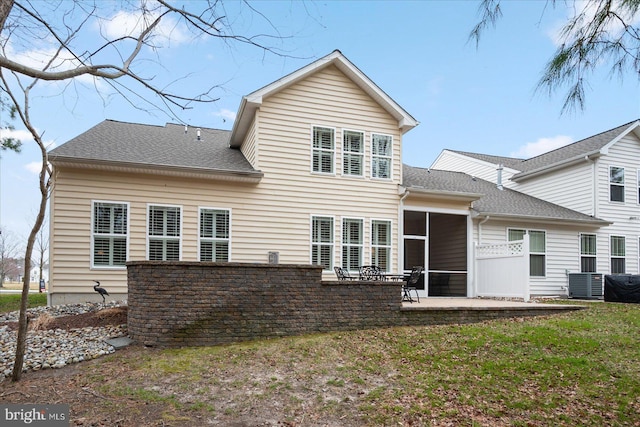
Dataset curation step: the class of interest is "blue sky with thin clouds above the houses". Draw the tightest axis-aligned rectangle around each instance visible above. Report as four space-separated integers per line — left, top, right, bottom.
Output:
0 1 640 244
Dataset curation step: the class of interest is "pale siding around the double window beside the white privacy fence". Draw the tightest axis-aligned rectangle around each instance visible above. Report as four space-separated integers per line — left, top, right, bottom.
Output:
473 220 595 296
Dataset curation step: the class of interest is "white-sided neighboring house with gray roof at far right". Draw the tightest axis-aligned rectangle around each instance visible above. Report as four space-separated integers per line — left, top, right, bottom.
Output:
432 120 640 280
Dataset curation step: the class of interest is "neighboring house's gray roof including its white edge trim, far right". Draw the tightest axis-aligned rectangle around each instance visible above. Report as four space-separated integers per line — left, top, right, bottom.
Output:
449 120 640 181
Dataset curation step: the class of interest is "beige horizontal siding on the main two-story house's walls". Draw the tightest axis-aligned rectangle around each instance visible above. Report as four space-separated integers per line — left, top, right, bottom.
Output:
50 66 410 300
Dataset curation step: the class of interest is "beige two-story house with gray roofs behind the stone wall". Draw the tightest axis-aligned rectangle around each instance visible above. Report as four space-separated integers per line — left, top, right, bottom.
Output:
50 51 607 304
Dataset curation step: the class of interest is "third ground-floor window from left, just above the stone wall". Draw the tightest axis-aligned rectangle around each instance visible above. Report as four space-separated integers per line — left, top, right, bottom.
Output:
199 208 230 262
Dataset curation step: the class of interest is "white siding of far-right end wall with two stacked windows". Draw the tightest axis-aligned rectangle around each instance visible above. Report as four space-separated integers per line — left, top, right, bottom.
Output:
597 134 640 274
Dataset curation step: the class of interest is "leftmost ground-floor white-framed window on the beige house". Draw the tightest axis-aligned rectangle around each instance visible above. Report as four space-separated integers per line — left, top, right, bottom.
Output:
91 202 129 267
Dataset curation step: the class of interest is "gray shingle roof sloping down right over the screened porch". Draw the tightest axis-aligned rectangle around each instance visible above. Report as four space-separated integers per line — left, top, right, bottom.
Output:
402 165 609 227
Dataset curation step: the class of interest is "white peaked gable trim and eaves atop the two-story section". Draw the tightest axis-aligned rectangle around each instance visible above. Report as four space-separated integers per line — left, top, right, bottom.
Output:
230 50 418 148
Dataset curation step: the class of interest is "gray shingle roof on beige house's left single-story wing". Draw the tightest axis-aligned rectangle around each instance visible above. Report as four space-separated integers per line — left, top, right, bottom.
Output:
49 120 262 182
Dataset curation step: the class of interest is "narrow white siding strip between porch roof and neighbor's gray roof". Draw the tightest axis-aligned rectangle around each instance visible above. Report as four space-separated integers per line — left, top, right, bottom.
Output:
431 150 518 188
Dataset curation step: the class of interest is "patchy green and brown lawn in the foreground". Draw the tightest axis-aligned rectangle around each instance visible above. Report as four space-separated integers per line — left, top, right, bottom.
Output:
72 302 640 427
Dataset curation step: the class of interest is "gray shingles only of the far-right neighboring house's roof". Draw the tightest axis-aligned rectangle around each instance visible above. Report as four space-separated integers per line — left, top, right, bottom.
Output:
451 120 638 178
